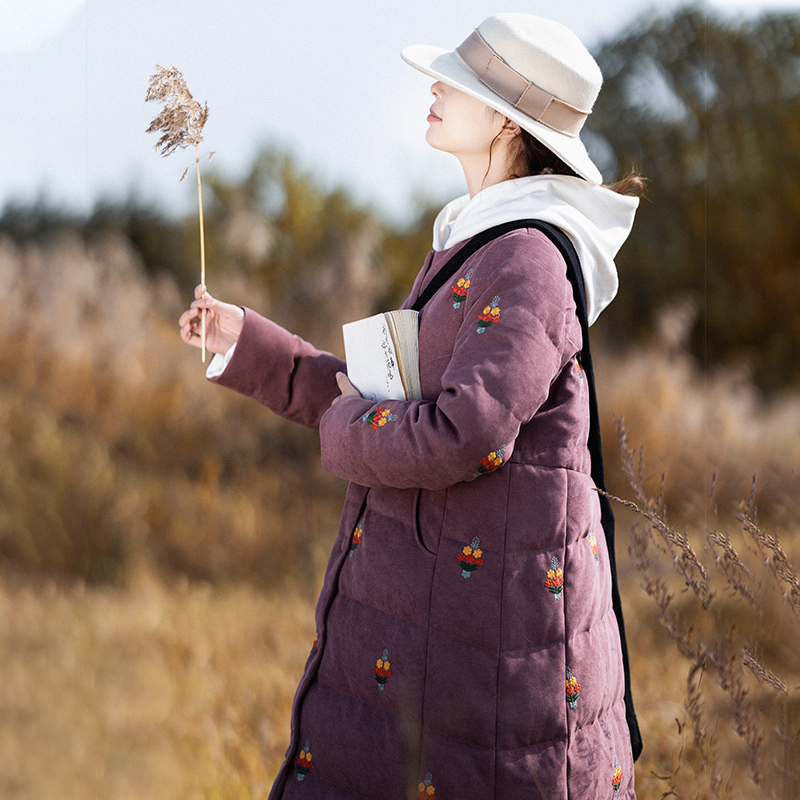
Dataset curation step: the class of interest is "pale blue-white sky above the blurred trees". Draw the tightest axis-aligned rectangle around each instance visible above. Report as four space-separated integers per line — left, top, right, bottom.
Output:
0 0 800 218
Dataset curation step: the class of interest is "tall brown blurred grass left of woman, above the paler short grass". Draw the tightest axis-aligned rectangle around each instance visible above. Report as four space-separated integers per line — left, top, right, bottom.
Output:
0 235 342 584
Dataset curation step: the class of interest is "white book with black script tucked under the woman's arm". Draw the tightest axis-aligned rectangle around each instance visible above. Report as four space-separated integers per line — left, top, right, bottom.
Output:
342 309 422 403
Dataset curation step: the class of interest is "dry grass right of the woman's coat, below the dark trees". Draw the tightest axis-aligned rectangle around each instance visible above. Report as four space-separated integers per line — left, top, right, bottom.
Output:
596 308 800 799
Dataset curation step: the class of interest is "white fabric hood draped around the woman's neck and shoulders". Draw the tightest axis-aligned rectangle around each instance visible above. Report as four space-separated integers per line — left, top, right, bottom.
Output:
433 175 639 325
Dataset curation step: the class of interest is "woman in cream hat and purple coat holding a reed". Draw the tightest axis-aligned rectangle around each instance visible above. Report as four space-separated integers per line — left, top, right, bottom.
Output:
180 14 637 800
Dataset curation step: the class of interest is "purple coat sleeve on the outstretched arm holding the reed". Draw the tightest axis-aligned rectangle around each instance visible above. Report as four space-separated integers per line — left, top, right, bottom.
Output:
211 308 345 428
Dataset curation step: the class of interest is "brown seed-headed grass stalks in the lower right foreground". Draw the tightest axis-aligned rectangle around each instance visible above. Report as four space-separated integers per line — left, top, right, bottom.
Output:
607 420 800 800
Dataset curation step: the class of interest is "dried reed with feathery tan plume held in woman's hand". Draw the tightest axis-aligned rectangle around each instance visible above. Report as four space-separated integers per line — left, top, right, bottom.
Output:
145 64 213 364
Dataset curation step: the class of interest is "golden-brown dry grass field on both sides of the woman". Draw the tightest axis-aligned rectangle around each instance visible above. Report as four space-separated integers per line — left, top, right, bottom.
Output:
0 230 800 800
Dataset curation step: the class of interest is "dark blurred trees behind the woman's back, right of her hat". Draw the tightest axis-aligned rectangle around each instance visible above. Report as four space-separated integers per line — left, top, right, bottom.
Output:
590 7 800 392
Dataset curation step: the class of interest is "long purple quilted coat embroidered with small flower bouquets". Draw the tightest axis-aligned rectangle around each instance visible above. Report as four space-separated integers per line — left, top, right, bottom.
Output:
216 230 634 800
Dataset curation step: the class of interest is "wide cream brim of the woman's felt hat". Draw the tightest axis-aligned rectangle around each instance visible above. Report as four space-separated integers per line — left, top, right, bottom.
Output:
400 44 603 185
